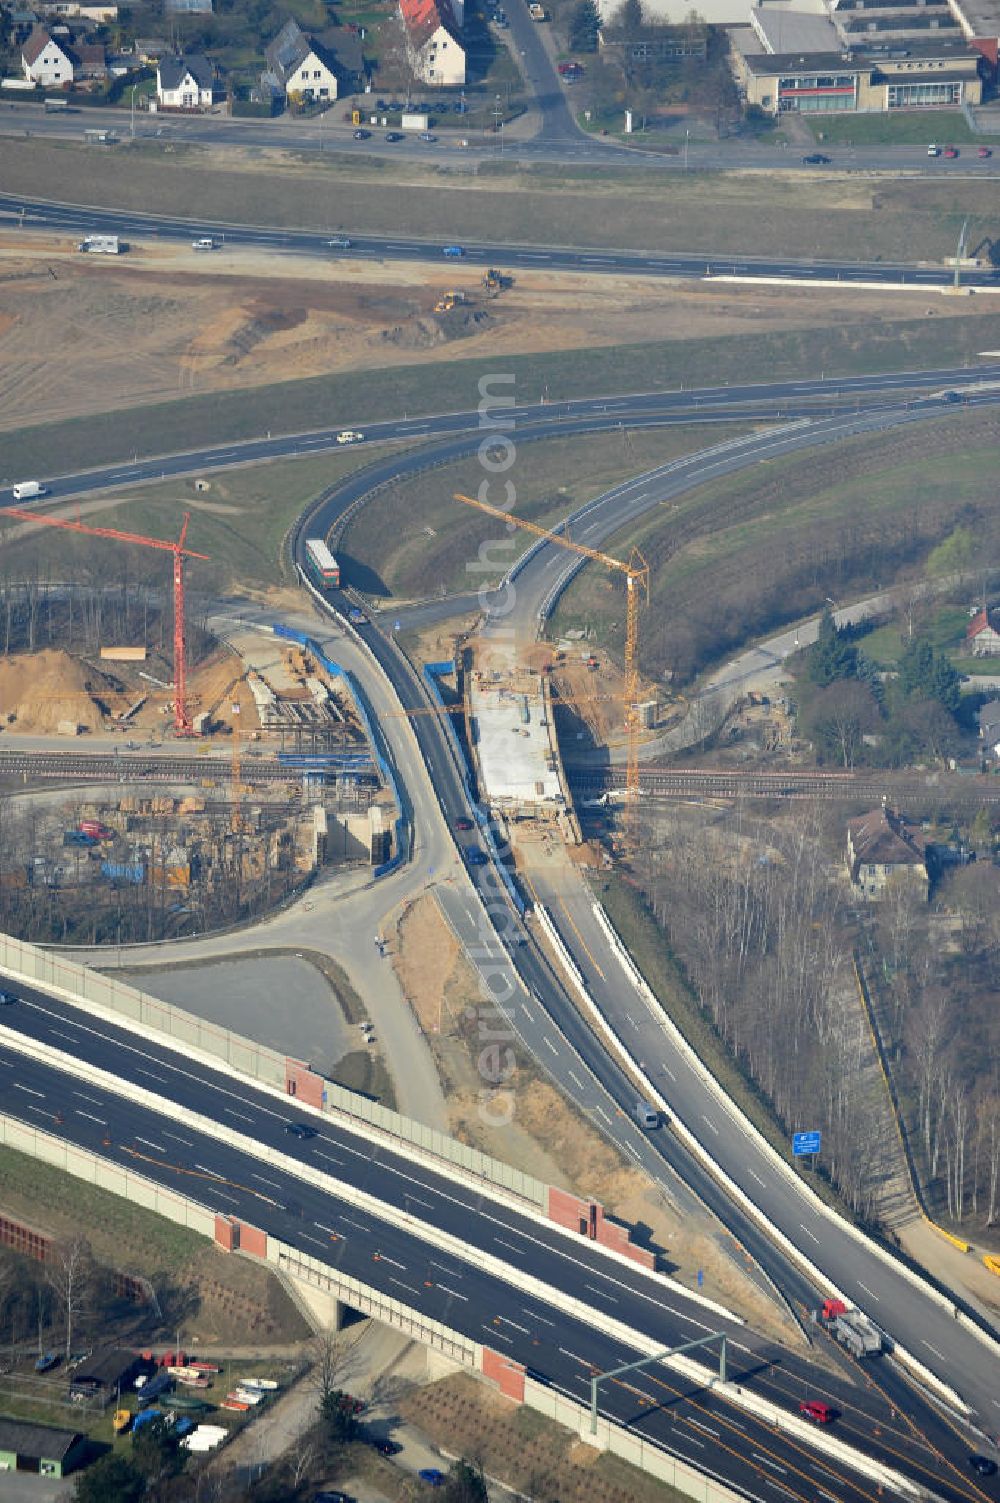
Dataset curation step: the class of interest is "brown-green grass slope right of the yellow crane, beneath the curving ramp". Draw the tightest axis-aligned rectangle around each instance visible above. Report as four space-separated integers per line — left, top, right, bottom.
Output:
550 410 997 678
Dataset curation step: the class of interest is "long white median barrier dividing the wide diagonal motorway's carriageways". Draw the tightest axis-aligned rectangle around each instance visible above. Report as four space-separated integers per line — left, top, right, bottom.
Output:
0 1052 923 1497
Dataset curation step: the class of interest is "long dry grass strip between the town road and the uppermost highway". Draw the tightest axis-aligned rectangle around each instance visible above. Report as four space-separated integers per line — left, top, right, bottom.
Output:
0 133 994 260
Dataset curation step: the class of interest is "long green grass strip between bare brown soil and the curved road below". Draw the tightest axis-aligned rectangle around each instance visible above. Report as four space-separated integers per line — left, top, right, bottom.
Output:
0 308 1000 482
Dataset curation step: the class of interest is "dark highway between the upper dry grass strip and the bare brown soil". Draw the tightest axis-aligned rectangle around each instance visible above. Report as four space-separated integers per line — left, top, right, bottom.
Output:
0 194 1000 290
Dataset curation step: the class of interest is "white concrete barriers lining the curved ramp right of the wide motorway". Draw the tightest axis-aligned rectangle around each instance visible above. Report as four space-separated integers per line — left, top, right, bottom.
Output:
594 903 974 1414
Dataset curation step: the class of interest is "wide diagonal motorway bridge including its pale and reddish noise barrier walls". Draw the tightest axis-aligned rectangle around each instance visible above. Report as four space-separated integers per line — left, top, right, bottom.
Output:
0 941 986 1503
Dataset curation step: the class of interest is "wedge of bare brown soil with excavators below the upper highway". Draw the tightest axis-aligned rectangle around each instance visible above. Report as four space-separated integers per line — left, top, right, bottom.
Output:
0 230 980 428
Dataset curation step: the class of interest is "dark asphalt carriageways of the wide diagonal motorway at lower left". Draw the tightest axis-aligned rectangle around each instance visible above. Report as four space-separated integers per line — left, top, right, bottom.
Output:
0 987 992 1503
